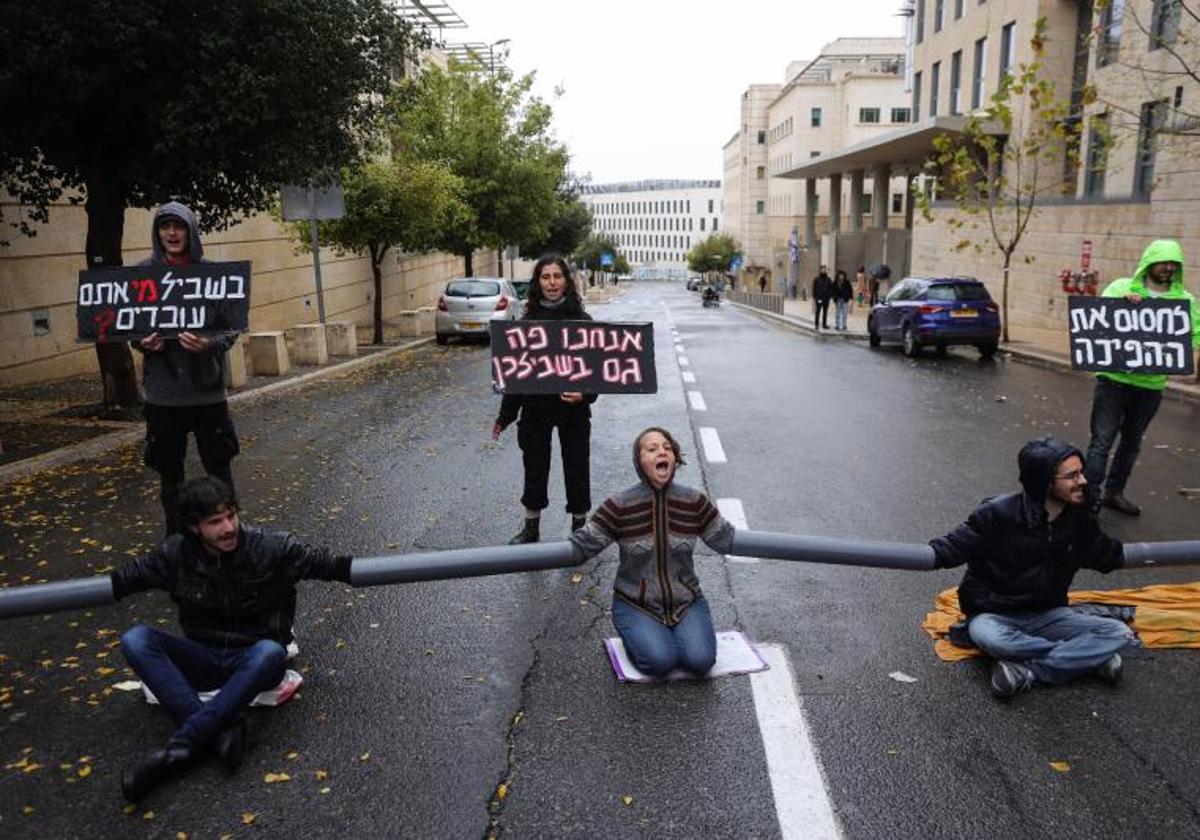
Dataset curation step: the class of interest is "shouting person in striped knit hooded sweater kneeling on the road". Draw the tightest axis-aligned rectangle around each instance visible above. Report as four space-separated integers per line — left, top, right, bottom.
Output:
571 426 733 677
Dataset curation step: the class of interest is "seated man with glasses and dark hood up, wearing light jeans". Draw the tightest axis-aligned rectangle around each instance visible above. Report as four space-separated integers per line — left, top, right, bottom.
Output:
930 437 1135 697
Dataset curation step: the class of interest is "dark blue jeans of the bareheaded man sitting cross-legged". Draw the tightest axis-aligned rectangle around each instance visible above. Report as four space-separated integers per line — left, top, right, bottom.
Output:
121 624 287 746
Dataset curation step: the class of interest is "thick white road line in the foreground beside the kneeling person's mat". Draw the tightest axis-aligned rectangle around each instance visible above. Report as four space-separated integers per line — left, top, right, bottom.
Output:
750 644 841 840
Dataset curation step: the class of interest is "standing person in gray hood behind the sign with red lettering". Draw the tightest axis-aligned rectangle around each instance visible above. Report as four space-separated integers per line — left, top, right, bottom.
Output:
131 202 240 535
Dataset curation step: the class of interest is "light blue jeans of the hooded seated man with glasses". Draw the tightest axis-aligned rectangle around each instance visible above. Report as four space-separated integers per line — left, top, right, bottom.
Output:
967 607 1136 683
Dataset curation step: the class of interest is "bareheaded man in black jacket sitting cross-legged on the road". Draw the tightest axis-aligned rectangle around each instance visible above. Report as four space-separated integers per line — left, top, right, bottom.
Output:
112 476 350 802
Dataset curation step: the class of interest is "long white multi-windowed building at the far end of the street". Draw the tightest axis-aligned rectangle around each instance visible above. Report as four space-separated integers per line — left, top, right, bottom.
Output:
581 180 724 276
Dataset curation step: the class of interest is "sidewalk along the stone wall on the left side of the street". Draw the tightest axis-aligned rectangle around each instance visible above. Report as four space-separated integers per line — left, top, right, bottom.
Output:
0 325 433 486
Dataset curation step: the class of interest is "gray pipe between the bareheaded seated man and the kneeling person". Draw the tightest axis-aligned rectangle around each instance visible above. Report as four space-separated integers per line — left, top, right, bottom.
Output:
350 540 583 587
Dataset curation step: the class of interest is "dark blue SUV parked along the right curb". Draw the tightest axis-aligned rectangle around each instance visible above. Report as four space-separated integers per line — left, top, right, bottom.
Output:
866 277 1000 359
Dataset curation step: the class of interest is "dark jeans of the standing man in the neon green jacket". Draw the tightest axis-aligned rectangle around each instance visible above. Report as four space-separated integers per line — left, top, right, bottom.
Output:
1084 378 1163 504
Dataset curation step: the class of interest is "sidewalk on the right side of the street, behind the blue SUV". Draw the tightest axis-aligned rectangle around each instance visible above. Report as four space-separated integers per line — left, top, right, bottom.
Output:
731 299 1200 403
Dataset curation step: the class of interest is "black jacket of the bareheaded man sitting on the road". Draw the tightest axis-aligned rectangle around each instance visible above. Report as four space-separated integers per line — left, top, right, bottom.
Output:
112 524 350 648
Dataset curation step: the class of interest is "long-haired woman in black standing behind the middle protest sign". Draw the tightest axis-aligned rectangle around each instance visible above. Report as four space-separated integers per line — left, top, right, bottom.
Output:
492 254 596 545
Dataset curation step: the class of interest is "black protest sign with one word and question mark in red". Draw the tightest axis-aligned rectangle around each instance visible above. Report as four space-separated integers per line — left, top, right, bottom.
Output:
76 262 250 342
